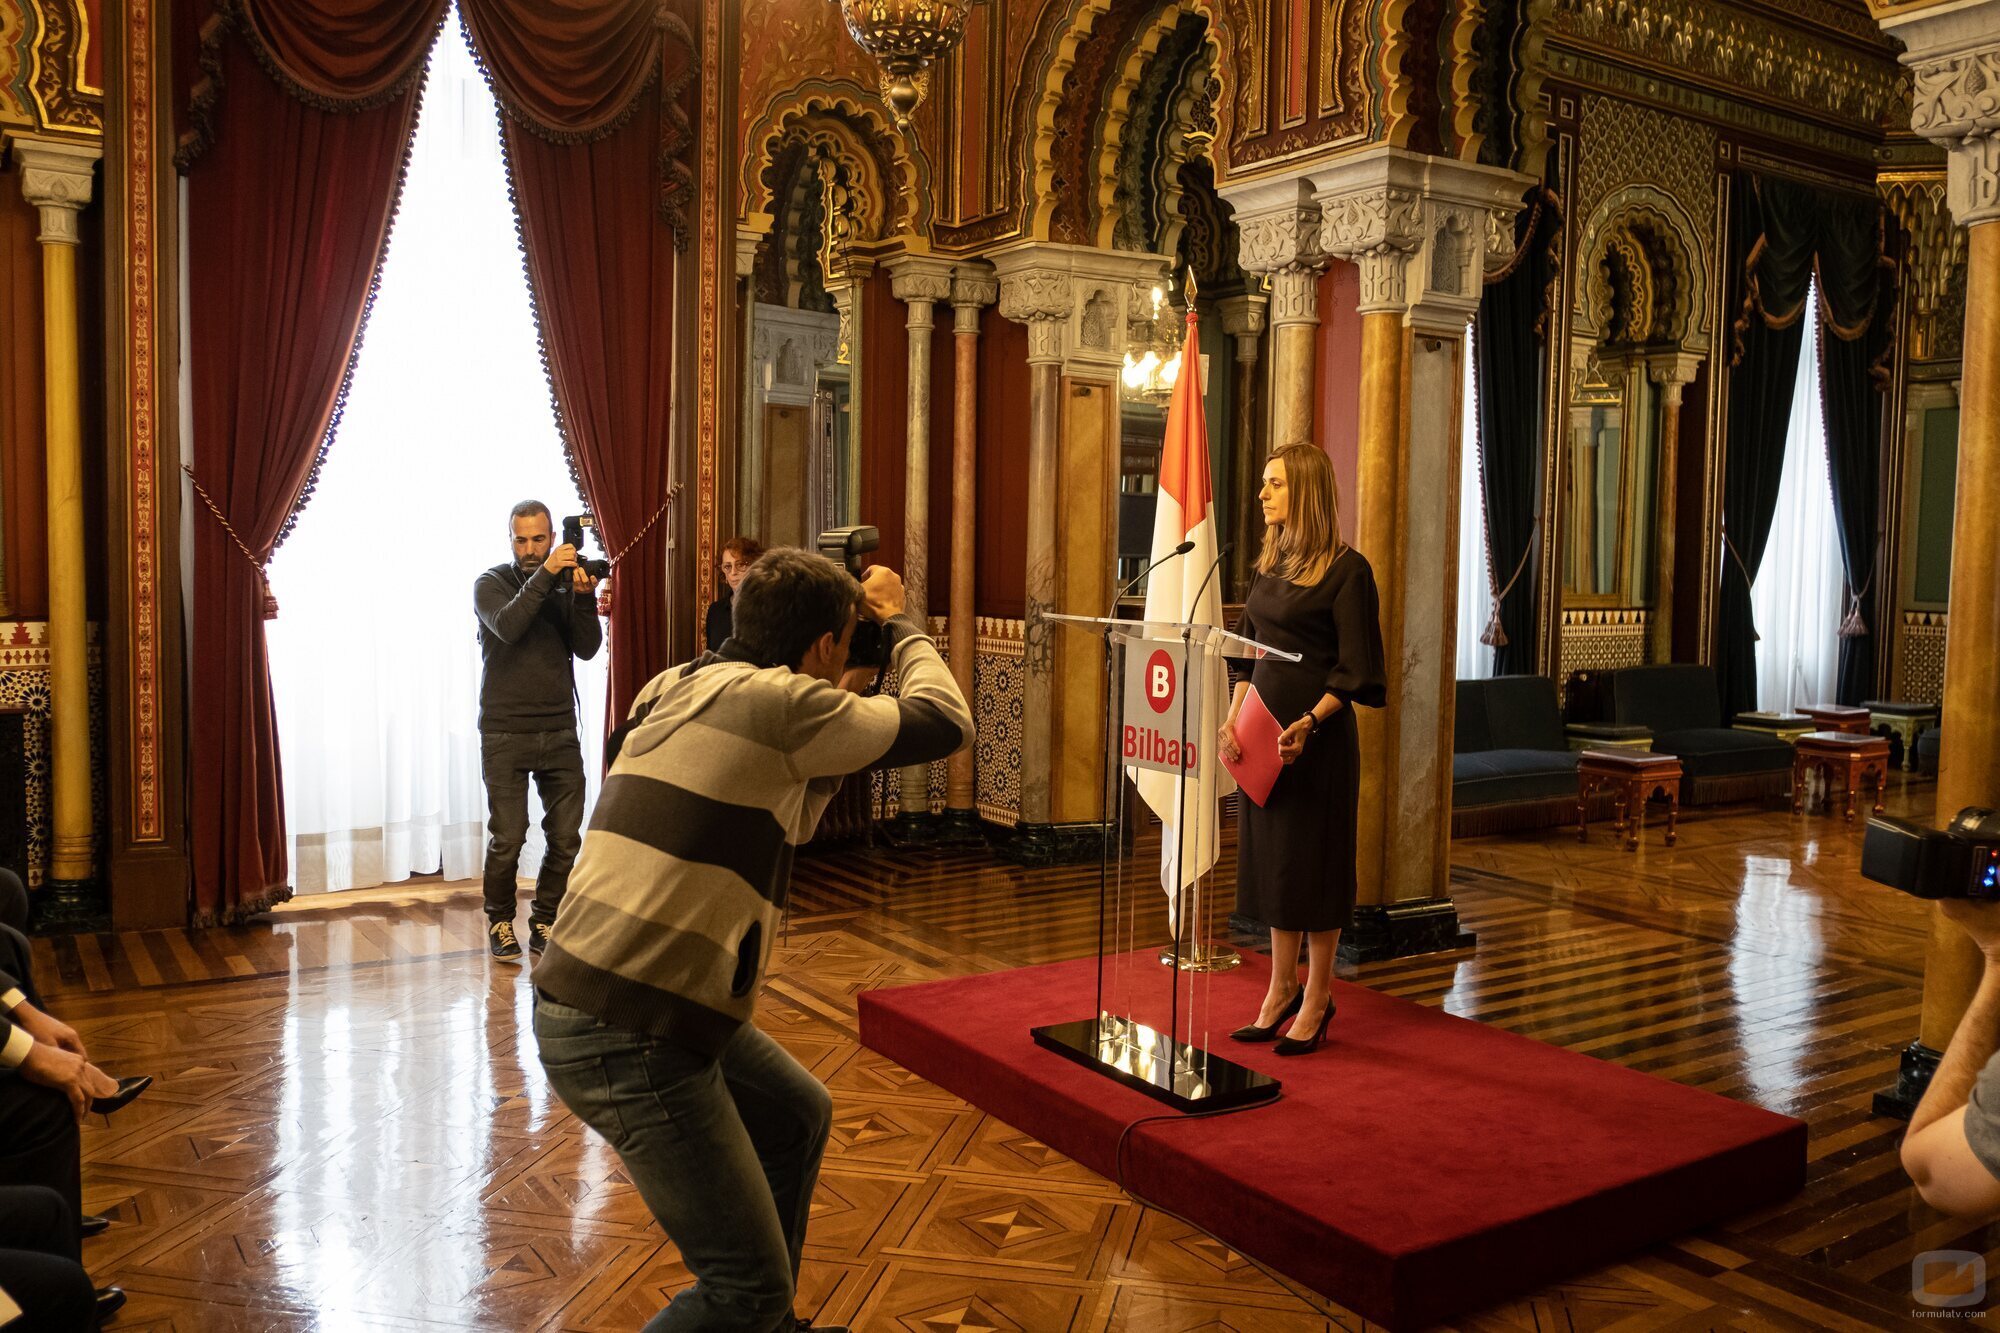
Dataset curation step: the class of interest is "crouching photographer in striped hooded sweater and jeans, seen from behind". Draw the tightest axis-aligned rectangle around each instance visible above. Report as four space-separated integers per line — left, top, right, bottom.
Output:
534 548 972 1333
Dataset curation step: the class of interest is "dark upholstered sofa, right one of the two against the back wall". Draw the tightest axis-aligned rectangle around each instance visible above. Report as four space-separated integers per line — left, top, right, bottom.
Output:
1608 664 1792 805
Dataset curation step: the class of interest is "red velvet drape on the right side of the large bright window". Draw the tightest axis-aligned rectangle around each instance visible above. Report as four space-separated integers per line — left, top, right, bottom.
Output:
460 0 694 725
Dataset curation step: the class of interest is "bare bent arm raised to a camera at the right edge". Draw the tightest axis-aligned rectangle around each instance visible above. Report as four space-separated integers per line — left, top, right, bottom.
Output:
1902 901 2000 1217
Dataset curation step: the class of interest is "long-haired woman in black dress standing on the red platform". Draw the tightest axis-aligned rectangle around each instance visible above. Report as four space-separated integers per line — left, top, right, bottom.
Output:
1220 444 1386 1055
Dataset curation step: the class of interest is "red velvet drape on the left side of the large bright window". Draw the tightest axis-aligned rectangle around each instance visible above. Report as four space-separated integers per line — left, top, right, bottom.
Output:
182 0 444 912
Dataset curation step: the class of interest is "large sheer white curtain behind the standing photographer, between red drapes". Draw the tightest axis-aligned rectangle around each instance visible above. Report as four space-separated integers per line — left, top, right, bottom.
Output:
266 10 606 893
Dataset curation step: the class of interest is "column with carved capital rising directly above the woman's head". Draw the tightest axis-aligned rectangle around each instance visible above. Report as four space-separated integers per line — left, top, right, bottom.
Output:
1224 178 1326 454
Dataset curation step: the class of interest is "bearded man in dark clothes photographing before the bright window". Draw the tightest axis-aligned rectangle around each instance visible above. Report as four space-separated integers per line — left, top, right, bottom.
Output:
472 500 604 963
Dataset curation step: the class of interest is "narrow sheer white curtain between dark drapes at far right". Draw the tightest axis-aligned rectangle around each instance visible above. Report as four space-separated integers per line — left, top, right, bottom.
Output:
1750 286 1842 711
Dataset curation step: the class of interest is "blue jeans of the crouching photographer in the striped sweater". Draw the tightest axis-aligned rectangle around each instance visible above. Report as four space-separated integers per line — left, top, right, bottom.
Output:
534 993 834 1333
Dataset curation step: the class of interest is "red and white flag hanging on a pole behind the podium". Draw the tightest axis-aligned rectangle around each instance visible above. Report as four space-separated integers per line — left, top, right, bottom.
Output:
1130 304 1236 913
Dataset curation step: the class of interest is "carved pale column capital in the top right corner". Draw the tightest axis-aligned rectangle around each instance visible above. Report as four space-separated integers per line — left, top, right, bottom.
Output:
1882 0 2000 226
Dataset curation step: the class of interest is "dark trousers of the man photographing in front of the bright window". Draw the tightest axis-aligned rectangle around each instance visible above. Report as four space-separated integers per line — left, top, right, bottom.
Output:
480 729 584 925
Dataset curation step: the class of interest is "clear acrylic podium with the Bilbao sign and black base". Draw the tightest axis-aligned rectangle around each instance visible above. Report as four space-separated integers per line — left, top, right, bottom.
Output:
1032 614 1298 1111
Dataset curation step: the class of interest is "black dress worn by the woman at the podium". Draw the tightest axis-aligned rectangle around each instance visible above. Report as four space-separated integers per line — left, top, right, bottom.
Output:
1236 546 1386 931
